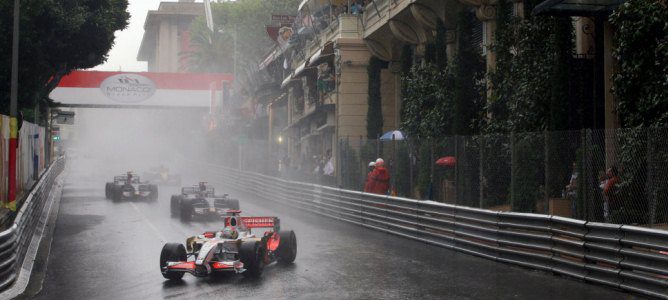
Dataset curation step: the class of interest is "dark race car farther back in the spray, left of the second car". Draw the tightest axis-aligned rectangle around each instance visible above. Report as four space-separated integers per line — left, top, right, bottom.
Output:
105 172 158 201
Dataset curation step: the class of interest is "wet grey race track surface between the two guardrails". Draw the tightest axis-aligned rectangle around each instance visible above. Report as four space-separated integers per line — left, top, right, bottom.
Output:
28 158 633 299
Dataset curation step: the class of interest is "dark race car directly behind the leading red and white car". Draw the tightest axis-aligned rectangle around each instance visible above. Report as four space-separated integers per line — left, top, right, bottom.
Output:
170 182 239 221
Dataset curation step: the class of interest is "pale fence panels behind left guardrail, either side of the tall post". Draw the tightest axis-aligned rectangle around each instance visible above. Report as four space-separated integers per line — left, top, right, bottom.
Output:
0 116 48 210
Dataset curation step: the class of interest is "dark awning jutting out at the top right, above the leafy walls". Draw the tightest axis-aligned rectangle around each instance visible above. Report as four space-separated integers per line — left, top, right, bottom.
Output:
531 0 626 17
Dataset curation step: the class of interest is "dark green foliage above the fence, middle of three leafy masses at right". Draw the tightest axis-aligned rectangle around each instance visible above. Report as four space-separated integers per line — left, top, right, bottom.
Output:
483 1 573 132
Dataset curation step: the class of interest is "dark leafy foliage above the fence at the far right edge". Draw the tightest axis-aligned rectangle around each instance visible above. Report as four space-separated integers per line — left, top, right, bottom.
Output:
610 0 668 127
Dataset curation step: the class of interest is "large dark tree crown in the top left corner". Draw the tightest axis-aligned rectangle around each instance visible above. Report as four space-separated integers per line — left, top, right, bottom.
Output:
0 0 130 119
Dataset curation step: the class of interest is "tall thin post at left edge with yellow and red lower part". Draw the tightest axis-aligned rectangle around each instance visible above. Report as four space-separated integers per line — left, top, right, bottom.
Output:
7 0 20 211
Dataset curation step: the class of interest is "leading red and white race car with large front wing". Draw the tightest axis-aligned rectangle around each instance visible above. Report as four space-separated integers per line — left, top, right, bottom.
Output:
160 210 297 280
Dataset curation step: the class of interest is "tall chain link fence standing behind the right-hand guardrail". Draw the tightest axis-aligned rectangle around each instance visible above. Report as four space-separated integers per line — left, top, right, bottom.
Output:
206 128 668 228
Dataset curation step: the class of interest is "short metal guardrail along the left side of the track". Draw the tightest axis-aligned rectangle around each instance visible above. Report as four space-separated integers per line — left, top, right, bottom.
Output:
0 158 65 291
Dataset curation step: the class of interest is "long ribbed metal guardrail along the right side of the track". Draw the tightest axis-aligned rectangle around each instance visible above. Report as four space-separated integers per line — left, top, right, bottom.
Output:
192 164 668 299
